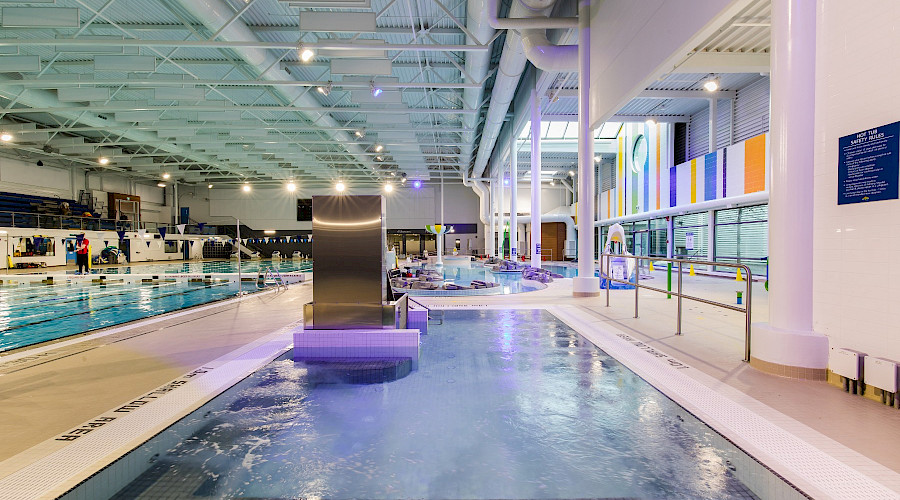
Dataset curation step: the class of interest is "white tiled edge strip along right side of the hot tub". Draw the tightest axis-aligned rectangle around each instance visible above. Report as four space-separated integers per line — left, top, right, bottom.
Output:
545 305 900 499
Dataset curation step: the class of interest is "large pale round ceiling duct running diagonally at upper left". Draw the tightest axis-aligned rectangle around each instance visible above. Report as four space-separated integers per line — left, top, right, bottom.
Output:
179 0 371 173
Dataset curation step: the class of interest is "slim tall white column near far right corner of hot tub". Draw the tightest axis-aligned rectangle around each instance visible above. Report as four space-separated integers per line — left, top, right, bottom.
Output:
572 0 600 297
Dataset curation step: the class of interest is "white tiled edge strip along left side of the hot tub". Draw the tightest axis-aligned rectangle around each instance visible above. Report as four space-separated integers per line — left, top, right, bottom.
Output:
0 319 302 500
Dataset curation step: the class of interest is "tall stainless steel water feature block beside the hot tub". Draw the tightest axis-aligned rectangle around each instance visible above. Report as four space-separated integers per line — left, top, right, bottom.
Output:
304 195 386 330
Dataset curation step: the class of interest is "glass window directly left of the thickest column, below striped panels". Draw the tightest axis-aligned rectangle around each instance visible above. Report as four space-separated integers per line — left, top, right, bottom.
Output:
716 205 769 275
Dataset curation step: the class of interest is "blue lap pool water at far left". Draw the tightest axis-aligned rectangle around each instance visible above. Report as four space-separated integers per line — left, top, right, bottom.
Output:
0 283 257 352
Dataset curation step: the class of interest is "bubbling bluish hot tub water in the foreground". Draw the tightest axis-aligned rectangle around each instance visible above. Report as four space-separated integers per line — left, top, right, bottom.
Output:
114 310 755 499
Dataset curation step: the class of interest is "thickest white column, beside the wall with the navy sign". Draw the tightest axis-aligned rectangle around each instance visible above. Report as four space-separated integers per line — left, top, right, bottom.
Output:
750 0 828 378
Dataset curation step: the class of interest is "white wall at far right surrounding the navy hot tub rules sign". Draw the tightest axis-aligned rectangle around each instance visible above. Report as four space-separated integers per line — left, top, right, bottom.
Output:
812 0 900 360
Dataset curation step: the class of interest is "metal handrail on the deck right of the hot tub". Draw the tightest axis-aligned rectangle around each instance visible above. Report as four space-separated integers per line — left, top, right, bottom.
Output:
600 253 753 362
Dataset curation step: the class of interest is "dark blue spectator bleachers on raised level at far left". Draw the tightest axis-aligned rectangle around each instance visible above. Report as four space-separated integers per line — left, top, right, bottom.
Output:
0 192 102 229
